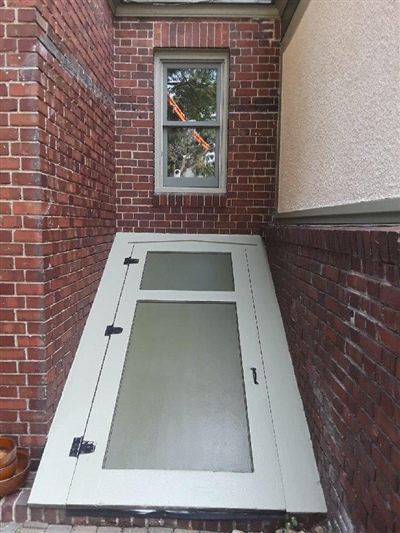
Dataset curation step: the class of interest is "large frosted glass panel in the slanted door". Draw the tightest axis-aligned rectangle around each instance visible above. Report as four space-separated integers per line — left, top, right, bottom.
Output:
103 302 253 472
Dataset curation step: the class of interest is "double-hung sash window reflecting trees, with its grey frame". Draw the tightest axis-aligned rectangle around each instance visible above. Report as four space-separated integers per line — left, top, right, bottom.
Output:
155 50 228 193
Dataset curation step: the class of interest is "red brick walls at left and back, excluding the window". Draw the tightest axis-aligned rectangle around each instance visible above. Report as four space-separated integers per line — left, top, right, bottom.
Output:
0 7 279 463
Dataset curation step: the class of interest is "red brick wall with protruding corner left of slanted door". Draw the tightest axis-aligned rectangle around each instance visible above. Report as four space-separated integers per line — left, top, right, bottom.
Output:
0 0 115 466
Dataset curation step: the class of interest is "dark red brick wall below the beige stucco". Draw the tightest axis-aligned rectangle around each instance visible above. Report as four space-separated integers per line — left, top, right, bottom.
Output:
263 225 400 533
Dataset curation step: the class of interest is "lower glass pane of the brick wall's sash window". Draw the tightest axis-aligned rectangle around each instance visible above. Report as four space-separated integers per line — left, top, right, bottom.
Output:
167 127 217 178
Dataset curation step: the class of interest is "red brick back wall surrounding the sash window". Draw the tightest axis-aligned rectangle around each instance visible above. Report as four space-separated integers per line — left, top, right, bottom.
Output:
115 19 280 233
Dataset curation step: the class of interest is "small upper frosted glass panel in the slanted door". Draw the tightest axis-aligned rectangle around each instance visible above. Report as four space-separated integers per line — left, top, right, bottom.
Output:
140 252 235 291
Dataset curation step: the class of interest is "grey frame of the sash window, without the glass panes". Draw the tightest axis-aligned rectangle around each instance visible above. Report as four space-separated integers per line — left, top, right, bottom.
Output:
154 49 229 194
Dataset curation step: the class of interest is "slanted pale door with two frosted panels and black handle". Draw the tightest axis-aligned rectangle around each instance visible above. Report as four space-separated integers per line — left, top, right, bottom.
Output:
67 242 285 510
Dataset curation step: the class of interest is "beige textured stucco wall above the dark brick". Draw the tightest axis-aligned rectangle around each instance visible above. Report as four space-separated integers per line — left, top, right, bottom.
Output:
278 0 400 212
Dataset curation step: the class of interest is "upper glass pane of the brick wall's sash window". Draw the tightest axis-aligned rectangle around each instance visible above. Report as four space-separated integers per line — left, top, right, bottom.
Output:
167 68 218 122
